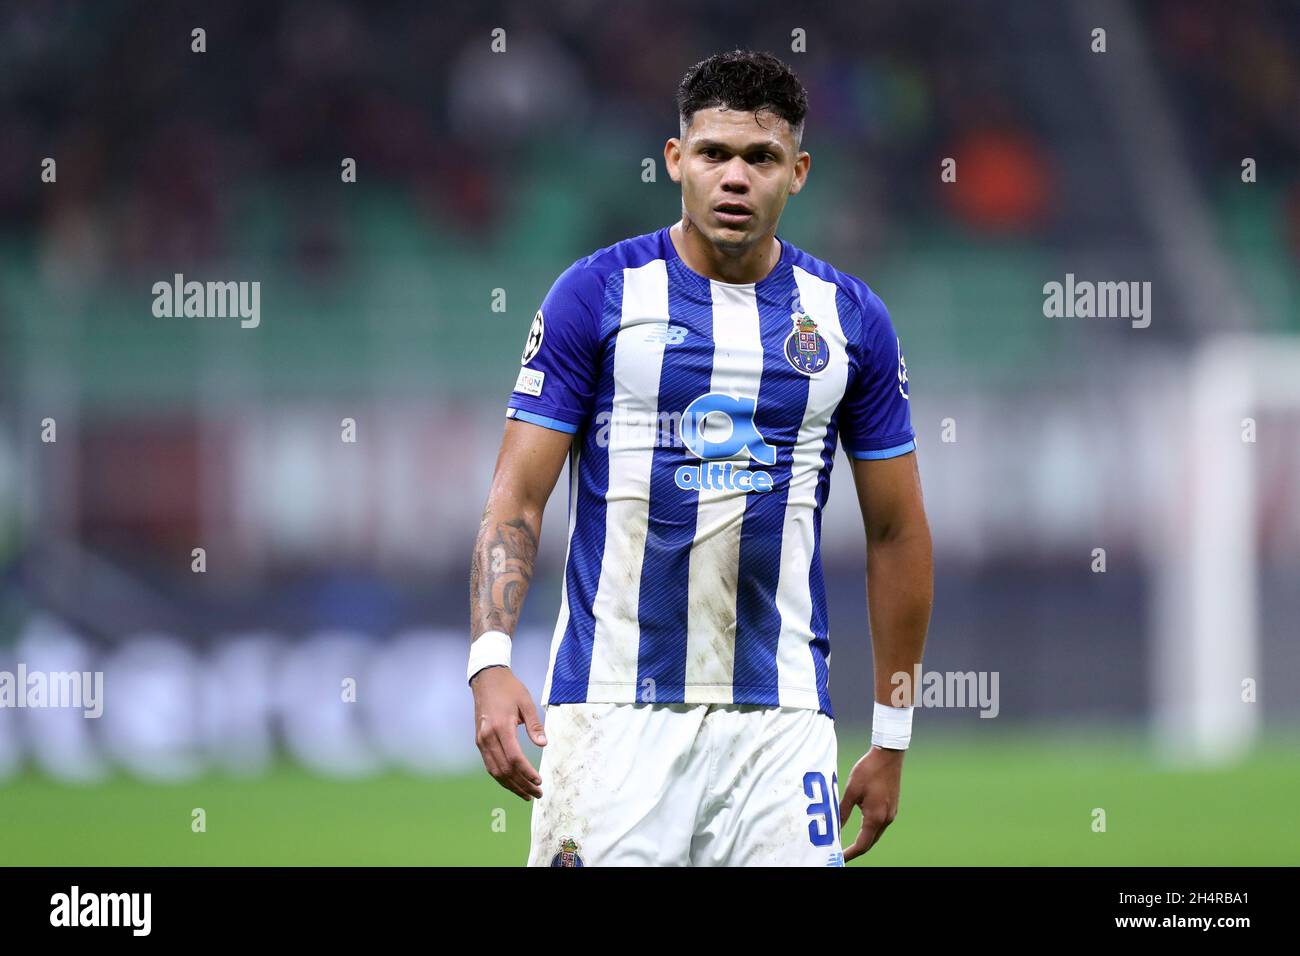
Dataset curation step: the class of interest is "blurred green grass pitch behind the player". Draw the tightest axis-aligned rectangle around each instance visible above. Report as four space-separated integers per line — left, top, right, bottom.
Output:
0 728 1300 866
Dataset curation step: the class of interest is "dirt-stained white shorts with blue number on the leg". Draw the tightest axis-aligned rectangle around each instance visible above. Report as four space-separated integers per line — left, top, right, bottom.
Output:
528 704 844 866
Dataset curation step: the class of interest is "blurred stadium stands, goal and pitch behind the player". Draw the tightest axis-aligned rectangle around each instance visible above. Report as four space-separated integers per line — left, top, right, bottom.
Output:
0 0 1300 865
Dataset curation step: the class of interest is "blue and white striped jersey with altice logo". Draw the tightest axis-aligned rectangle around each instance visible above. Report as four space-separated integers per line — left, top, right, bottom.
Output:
506 226 915 715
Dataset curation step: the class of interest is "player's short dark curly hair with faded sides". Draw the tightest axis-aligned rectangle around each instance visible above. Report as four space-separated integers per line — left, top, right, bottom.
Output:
677 49 809 144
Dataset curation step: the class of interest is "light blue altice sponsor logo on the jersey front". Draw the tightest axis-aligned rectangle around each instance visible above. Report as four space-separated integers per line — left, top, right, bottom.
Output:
675 392 776 492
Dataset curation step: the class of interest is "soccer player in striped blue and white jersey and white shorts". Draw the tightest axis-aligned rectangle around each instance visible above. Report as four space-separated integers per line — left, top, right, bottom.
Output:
468 51 932 866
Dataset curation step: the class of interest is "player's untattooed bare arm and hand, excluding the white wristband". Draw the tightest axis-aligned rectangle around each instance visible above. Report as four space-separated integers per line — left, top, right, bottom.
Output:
840 453 935 861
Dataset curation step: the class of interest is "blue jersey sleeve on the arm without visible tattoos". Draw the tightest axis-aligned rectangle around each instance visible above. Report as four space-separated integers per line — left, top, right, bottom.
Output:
840 286 917 459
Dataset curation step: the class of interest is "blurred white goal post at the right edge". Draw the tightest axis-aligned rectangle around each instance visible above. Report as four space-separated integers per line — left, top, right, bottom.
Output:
1151 334 1300 766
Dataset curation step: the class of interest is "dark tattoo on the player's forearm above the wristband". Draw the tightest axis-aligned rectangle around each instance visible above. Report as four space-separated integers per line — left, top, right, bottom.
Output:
469 510 537 637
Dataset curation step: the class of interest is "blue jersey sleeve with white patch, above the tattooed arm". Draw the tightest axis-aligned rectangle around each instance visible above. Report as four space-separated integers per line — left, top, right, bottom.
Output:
506 260 605 433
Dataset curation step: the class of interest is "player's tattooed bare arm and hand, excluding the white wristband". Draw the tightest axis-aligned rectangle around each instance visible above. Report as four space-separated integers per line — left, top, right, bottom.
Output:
469 420 573 800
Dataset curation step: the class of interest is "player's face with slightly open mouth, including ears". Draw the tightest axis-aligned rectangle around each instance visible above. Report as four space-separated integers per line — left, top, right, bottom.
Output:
664 107 810 252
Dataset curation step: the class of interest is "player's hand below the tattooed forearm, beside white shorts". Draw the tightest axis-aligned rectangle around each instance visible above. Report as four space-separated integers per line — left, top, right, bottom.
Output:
469 667 546 801
